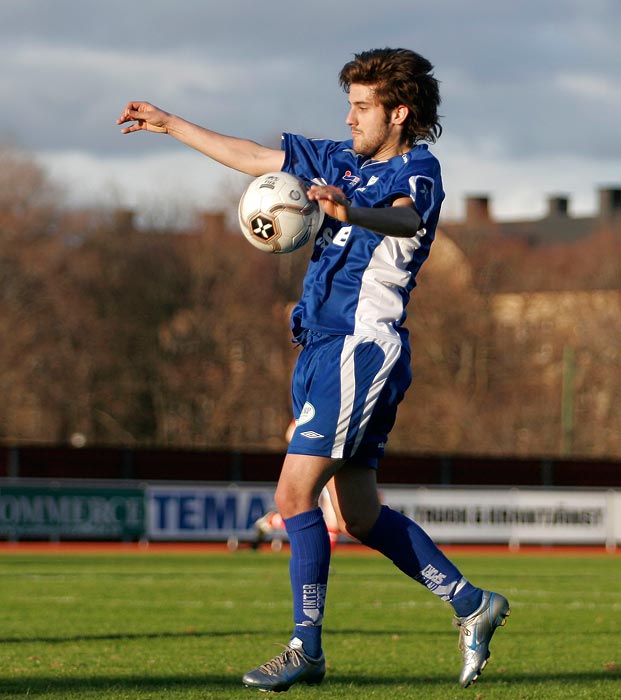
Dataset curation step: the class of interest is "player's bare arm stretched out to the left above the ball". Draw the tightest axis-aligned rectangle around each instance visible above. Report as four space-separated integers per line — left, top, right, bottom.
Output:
116 102 285 177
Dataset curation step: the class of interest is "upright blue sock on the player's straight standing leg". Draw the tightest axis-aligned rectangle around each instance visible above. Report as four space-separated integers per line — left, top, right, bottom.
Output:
284 508 330 658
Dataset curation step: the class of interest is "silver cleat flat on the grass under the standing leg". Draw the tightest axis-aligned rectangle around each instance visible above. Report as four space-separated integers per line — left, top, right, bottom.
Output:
242 638 326 693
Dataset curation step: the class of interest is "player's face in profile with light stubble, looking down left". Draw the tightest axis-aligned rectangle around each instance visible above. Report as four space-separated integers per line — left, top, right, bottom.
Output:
345 83 404 160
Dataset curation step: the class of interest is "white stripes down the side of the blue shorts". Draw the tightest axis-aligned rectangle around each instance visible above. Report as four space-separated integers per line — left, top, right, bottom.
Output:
330 335 401 459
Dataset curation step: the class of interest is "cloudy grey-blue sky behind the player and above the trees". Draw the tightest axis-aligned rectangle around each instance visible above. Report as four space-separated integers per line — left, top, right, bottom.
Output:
0 0 621 219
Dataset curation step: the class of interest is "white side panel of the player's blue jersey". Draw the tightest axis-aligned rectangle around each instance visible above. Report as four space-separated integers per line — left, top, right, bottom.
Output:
354 234 426 343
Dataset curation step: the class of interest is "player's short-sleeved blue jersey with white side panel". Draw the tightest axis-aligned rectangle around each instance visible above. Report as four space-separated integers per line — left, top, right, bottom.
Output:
282 134 444 343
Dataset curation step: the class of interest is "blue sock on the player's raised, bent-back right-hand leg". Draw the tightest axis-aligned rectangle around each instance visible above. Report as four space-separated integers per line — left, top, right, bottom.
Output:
363 506 483 617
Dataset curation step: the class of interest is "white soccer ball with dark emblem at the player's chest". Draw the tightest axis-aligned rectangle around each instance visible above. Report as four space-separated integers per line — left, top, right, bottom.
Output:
238 172 323 253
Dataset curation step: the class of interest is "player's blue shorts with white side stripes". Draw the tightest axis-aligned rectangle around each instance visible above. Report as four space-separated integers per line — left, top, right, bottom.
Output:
288 332 412 468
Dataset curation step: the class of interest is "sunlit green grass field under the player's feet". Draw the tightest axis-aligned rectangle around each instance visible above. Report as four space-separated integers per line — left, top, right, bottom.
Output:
0 550 621 700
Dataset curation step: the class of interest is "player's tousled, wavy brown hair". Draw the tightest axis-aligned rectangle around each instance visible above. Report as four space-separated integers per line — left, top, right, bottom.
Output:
339 48 442 145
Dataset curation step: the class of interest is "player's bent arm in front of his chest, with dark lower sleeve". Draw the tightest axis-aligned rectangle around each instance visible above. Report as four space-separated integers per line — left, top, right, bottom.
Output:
308 185 421 238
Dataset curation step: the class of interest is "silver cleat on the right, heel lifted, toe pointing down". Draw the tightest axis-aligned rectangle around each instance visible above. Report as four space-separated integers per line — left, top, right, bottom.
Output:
456 591 511 688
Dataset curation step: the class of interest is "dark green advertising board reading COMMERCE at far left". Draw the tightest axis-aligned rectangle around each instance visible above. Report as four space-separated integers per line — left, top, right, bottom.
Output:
0 482 145 541
